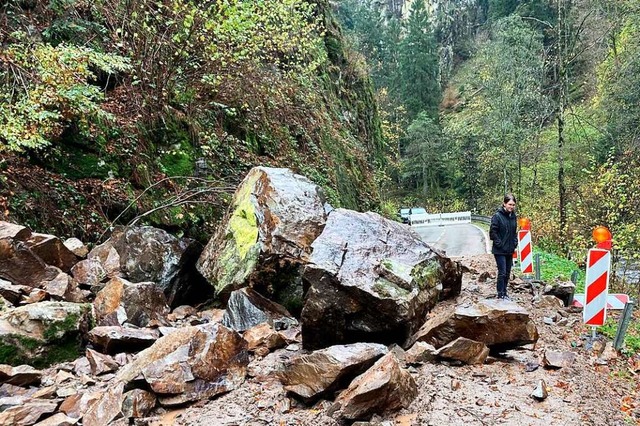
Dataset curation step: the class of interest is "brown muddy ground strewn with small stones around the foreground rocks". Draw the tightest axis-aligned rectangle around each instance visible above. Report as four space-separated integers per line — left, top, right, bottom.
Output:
152 255 640 426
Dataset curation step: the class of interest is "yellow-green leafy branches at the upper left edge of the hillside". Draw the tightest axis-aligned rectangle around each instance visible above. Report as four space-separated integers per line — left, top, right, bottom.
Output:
0 40 129 151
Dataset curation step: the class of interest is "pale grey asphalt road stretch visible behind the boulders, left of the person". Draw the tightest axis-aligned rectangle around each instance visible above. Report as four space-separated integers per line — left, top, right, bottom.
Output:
412 223 488 256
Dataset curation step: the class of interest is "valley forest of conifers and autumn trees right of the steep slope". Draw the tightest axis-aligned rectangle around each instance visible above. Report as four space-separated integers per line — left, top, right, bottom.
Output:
339 0 640 284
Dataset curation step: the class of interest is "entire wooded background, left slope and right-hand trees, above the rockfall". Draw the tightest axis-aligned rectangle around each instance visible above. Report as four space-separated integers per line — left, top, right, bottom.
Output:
0 0 640 290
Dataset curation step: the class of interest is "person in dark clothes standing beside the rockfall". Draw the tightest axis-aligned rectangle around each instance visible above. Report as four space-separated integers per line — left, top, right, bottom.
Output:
489 194 518 300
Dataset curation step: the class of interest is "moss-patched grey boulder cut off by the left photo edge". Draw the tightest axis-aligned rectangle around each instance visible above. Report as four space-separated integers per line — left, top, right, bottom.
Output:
0 302 91 366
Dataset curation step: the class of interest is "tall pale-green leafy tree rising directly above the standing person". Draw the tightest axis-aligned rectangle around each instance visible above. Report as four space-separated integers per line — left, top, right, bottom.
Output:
445 16 552 212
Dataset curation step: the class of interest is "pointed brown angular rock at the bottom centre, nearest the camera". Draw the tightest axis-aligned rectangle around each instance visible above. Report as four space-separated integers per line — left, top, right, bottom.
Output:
334 353 418 420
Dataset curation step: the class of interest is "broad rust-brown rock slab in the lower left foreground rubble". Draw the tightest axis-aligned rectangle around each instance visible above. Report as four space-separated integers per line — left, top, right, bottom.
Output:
115 324 249 406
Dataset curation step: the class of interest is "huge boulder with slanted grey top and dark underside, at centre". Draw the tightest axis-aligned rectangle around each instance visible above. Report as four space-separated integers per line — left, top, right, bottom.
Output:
301 209 461 350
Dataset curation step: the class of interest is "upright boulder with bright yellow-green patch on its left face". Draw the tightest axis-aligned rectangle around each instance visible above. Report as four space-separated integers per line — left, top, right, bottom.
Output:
197 167 326 306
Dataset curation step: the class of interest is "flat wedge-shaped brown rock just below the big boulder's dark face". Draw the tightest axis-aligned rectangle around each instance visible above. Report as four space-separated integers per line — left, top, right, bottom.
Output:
278 343 387 402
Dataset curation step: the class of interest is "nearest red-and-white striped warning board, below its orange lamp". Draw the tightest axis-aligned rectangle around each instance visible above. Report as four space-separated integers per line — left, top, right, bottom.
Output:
582 249 611 326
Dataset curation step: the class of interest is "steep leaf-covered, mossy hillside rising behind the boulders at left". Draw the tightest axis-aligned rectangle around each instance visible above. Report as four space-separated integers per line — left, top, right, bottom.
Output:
0 0 385 245
